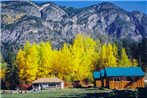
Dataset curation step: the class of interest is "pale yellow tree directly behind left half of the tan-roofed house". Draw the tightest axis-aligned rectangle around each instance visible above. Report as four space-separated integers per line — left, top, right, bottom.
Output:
37 42 53 78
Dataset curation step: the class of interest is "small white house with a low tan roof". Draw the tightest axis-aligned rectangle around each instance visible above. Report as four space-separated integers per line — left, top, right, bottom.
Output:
32 78 64 90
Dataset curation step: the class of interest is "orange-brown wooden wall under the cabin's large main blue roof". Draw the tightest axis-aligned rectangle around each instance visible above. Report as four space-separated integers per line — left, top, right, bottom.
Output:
109 77 144 89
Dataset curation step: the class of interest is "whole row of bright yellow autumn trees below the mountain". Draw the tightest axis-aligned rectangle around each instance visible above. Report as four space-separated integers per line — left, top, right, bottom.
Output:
16 34 138 83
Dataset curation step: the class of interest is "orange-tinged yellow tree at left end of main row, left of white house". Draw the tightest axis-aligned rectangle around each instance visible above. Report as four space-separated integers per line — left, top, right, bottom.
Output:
16 42 39 84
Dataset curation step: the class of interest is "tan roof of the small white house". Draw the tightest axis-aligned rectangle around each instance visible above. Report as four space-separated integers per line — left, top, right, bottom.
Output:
32 78 64 83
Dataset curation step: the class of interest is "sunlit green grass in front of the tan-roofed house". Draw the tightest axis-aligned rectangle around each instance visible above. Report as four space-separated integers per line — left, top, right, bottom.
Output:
1 88 112 98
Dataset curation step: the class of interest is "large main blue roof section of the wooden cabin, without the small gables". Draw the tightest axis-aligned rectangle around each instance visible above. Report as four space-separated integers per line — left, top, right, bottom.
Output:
105 67 144 76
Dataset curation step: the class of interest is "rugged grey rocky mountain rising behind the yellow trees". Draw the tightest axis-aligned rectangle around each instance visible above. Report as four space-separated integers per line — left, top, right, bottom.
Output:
1 1 147 52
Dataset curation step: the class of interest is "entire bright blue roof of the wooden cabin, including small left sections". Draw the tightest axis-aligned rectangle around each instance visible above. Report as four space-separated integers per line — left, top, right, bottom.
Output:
94 67 144 79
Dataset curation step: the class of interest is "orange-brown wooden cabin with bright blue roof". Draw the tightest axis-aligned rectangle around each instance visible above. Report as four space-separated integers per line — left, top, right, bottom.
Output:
94 67 144 89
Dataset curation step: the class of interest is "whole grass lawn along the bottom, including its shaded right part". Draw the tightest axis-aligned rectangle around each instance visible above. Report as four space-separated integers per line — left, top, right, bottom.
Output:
1 88 137 98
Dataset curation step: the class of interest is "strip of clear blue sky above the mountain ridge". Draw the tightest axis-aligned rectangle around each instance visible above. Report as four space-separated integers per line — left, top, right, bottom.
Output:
2 0 147 14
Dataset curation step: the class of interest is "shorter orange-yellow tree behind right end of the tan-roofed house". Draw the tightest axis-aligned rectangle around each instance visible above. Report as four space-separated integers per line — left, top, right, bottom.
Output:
52 44 73 81
